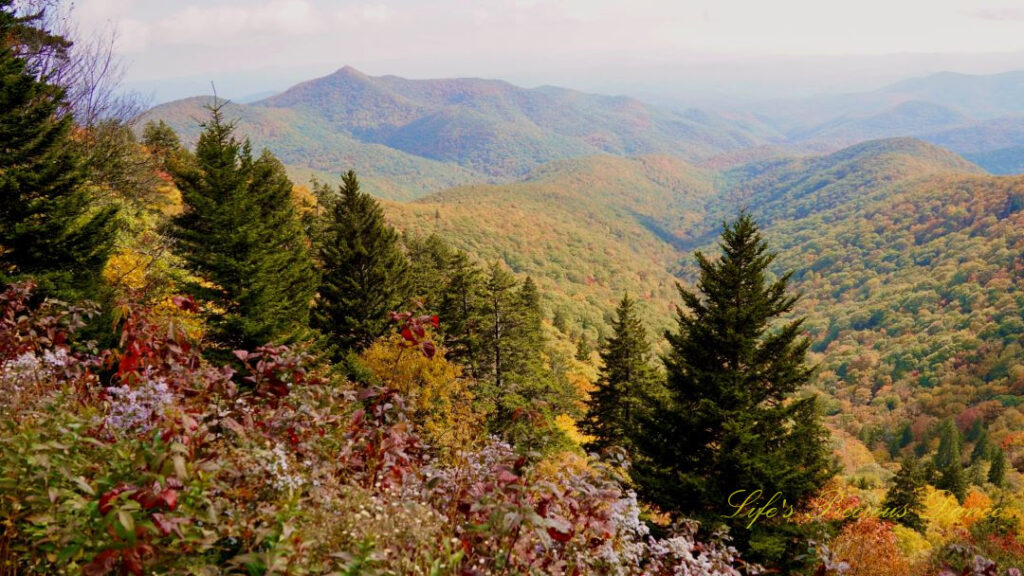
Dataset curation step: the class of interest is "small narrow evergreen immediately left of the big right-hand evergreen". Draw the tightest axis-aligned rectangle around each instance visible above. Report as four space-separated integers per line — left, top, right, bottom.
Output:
582 294 657 454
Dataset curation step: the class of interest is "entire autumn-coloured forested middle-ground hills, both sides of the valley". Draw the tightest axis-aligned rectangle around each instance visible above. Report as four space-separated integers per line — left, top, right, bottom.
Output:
387 138 1024 464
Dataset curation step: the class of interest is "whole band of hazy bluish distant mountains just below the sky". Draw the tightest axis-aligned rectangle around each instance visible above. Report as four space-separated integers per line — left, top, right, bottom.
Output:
147 67 1024 200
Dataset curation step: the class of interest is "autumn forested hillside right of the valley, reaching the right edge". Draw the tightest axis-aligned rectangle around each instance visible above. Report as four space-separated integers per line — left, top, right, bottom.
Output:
683 139 1024 463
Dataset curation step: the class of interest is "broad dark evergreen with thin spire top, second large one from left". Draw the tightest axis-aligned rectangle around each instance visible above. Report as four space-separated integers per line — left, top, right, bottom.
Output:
170 105 315 348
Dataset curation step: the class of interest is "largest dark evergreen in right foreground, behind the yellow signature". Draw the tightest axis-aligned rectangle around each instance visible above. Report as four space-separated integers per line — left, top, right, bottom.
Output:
635 213 835 545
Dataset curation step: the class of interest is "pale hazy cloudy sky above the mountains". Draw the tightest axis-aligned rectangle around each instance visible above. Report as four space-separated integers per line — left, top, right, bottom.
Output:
75 0 1024 101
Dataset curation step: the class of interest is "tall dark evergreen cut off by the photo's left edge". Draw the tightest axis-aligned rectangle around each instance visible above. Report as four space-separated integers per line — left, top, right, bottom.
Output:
0 0 117 300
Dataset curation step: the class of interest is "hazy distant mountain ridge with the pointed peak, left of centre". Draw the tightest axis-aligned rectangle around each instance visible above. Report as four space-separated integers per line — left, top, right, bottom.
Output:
144 67 765 200
